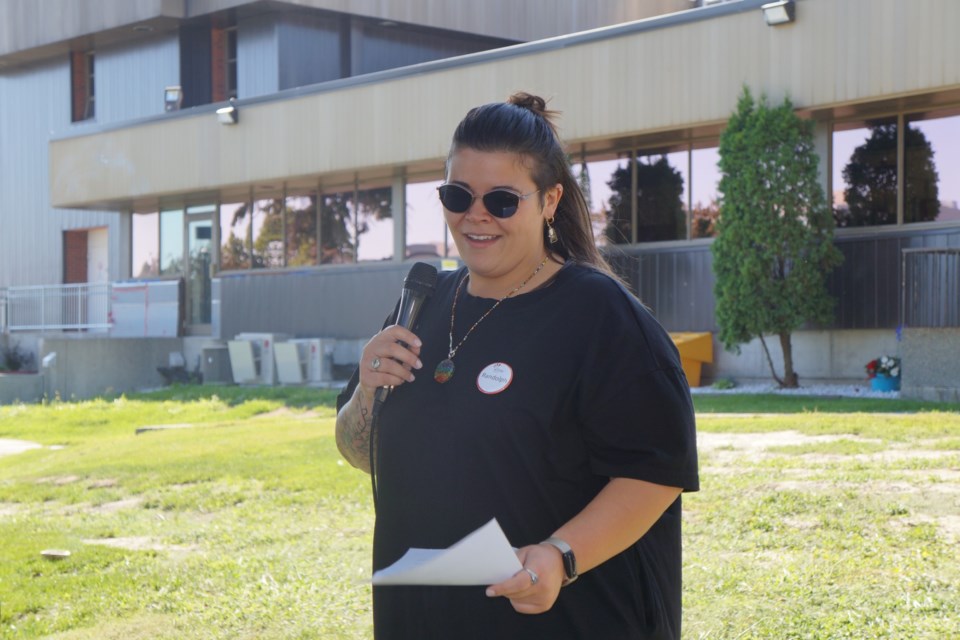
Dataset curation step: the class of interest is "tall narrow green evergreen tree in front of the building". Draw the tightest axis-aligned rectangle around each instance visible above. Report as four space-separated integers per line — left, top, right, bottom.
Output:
712 88 842 387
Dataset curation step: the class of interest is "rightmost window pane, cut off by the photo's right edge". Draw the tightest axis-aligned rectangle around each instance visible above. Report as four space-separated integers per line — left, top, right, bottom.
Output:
903 115 960 222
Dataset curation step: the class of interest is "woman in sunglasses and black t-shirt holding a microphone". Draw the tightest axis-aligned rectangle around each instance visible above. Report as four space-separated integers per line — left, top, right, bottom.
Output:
337 94 698 640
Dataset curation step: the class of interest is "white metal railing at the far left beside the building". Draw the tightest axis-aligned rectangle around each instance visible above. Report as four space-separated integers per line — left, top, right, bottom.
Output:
0 282 111 331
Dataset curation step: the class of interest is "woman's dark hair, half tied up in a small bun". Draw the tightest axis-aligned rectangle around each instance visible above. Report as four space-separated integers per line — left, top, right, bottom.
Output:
447 93 613 275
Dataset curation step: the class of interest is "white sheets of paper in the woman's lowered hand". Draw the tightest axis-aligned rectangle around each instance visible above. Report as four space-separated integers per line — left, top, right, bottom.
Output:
372 518 523 586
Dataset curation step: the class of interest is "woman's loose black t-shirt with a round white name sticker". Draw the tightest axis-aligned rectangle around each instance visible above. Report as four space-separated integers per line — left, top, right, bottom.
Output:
341 264 698 640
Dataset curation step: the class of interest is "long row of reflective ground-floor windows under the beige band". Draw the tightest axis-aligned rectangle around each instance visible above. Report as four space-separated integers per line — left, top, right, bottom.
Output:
132 105 960 277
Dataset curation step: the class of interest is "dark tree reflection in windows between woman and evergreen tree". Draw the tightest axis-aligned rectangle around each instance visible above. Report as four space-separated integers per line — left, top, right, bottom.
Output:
605 156 687 244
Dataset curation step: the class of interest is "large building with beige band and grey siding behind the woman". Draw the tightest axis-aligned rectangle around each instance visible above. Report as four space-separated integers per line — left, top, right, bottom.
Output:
0 0 960 397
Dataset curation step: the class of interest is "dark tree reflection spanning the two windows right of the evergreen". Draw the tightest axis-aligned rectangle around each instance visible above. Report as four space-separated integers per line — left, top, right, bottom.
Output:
834 122 940 227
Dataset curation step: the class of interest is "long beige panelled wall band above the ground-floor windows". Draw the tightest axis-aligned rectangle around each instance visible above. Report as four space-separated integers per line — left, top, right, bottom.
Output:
50 0 960 209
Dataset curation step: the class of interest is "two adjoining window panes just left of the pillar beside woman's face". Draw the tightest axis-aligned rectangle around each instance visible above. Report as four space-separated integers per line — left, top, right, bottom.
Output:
320 187 393 264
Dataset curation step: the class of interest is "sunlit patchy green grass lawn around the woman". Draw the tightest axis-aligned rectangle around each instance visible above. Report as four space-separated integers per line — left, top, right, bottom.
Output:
0 387 960 640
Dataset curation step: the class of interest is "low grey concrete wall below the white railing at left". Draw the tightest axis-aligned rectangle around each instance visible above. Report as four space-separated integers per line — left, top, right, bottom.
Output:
37 336 183 400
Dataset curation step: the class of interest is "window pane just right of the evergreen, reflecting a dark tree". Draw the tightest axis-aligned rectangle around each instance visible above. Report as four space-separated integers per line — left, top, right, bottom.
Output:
832 119 897 227
